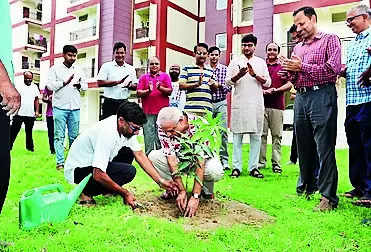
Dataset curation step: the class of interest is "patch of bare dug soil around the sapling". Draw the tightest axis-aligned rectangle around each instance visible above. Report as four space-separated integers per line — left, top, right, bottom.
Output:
135 192 273 230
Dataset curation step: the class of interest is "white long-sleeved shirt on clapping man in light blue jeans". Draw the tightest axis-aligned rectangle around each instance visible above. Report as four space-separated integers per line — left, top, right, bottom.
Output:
46 63 88 110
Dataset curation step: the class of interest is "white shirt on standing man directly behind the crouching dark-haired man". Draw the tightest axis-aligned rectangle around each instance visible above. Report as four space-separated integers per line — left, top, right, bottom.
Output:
97 60 138 100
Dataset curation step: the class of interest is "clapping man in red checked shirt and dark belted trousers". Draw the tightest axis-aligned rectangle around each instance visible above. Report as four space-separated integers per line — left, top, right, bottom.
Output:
280 7 341 211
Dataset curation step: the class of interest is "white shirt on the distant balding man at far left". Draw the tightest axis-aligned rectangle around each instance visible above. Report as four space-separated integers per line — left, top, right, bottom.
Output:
15 83 40 117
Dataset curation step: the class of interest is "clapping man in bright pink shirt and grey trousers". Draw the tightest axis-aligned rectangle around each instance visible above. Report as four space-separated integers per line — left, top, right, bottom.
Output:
137 57 172 155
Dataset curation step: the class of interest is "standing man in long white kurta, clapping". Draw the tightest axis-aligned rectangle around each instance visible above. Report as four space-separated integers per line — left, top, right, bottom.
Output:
226 34 271 178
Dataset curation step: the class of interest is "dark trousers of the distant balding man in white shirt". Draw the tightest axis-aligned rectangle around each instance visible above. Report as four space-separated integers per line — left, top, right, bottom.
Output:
10 115 35 151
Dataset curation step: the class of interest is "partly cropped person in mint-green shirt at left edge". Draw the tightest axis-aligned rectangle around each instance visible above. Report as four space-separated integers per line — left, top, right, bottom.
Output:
0 1 21 213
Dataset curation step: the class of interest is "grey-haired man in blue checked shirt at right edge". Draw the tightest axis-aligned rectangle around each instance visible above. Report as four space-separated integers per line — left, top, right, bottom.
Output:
344 5 371 207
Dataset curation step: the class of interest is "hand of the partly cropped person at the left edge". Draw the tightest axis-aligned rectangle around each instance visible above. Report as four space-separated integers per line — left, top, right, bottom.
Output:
0 82 21 116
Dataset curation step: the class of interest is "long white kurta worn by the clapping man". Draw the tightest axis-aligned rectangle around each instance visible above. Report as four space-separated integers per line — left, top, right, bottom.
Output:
226 55 272 134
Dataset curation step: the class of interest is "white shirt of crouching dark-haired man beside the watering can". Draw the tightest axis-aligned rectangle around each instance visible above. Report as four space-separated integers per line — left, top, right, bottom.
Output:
64 115 141 184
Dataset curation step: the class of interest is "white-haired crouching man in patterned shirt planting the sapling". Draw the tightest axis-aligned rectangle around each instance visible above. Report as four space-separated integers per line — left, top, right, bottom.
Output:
148 107 224 217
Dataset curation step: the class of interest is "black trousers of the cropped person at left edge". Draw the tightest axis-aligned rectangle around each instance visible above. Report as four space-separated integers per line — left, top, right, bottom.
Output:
0 104 10 213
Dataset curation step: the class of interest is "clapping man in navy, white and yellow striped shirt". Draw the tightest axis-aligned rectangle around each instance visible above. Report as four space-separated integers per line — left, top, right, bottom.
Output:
179 43 219 116
